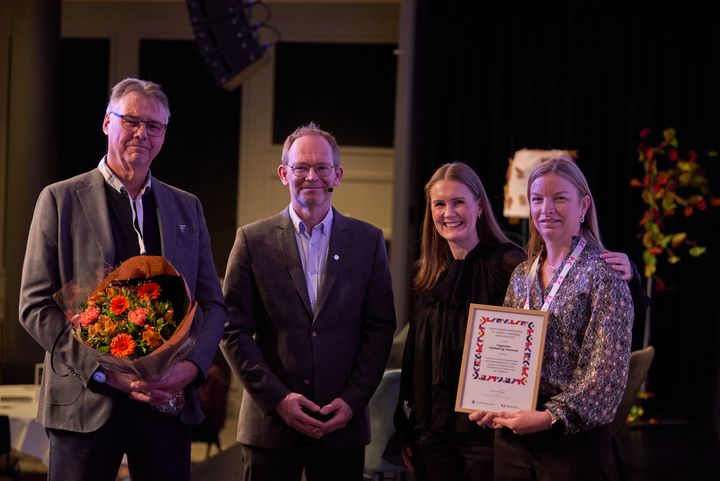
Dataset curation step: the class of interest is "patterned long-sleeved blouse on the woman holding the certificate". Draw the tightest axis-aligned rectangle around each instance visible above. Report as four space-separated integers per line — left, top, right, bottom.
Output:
505 237 633 434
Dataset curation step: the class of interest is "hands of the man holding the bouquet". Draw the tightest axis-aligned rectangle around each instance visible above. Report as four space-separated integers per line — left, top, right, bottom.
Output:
102 361 198 411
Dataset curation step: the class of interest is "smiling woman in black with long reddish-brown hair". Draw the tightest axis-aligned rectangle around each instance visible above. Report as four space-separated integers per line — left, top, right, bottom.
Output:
396 163 526 481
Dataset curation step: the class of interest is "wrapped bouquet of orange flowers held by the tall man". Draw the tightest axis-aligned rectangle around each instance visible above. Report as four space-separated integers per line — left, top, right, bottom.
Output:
54 256 196 386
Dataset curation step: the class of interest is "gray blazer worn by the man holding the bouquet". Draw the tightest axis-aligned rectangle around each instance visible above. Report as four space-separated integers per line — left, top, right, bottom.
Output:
20 169 225 432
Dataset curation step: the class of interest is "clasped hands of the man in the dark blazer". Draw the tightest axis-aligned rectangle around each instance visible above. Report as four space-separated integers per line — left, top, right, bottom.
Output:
275 392 353 439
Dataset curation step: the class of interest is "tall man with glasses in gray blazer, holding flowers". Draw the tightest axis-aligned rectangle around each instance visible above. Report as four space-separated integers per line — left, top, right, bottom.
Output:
20 78 225 481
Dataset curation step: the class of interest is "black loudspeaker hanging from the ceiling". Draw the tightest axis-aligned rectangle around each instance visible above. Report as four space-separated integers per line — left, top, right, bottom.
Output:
186 0 270 90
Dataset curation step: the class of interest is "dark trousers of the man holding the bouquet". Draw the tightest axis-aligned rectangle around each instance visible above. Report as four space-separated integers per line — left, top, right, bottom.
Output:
47 398 192 481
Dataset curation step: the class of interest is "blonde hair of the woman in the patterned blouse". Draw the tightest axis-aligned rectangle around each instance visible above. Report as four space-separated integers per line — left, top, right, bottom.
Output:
527 155 604 259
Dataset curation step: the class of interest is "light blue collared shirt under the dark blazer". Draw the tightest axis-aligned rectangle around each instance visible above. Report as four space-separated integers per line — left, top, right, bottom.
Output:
288 206 333 312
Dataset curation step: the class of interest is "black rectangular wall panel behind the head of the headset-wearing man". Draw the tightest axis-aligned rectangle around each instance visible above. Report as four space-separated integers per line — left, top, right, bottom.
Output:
272 42 397 148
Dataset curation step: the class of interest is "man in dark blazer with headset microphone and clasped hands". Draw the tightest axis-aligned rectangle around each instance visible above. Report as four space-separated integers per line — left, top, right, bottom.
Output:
221 123 395 481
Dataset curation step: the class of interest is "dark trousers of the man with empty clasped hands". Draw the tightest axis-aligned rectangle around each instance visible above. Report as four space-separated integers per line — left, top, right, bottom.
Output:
242 438 365 481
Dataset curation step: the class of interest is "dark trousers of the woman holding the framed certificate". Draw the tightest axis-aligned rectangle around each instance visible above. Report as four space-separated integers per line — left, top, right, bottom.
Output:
495 426 610 481
